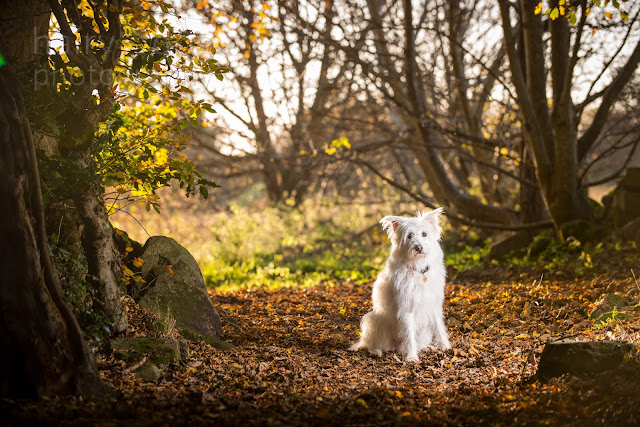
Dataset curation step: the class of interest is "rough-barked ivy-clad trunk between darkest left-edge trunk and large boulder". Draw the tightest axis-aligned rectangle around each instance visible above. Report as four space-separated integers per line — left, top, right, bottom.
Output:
0 0 127 331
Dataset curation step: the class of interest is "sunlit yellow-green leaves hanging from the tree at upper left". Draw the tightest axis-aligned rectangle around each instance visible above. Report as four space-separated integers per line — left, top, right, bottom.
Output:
41 0 226 212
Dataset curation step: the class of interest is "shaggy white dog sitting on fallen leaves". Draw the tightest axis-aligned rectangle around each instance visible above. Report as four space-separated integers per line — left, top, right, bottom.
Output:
350 208 451 362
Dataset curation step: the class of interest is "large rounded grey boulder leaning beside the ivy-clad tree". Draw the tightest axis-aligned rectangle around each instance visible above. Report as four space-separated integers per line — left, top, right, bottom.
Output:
134 236 222 338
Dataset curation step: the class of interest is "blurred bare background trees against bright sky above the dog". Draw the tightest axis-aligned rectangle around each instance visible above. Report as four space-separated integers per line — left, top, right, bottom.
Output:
178 1 640 229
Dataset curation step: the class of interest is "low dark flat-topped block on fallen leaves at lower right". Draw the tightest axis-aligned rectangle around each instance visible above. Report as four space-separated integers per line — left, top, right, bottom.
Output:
536 340 635 379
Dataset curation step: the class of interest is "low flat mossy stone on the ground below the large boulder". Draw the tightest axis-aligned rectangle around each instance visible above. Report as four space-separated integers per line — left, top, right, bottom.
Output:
111 337 181 365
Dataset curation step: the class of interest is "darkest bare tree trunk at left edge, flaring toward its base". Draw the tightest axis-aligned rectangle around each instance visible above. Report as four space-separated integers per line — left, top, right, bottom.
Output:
0 67 106 398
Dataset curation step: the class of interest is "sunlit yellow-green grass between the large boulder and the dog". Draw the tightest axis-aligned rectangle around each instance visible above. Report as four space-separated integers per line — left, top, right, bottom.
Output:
111 190 416 291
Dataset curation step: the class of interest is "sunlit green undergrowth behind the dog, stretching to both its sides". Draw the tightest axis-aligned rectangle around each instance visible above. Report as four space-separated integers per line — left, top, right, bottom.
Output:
113 191 636 291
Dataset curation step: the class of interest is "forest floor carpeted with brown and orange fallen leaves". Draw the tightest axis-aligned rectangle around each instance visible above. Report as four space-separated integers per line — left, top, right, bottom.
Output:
0 242 640 425
